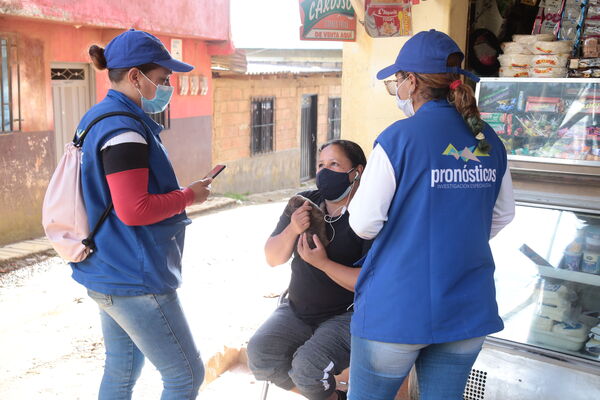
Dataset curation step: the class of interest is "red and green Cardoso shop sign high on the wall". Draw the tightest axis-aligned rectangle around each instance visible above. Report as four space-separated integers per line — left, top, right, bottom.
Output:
300 0 356 42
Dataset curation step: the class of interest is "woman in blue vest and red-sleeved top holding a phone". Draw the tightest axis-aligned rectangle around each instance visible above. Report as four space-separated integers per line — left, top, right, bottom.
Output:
71 29 210 400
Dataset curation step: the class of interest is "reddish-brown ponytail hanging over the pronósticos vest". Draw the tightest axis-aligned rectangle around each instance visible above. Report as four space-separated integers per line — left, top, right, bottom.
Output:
448 81 492 153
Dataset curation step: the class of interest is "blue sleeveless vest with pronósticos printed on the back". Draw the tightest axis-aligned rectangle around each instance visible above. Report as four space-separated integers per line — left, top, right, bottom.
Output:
351 100 507 344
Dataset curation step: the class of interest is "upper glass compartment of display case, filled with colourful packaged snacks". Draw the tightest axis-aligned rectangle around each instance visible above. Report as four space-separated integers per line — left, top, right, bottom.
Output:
476 78 600 166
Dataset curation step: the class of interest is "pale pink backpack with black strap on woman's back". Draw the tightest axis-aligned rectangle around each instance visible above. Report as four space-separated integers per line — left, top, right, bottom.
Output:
42 112 143 262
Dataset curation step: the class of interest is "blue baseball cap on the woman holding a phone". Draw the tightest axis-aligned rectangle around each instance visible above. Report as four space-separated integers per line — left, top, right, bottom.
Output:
104 29 194 72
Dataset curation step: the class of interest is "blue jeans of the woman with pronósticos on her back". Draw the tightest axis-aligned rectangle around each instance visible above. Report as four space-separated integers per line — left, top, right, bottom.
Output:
348 336 485 400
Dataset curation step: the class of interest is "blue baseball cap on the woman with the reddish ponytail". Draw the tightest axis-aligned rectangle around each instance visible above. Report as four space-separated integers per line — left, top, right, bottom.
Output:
377 29 479 82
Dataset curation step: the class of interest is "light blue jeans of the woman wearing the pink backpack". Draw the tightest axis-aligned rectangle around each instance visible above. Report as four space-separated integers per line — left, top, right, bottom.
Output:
88 290 204 400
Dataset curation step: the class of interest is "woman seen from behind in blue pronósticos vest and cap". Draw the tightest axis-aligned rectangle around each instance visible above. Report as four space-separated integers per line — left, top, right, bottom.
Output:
349 30 514 400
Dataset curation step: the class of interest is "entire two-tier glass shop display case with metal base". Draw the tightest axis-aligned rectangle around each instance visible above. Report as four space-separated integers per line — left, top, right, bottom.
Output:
474 78 600 400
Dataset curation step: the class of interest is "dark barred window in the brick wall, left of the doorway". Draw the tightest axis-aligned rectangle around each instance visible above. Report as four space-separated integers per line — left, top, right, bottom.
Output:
250 97 275 155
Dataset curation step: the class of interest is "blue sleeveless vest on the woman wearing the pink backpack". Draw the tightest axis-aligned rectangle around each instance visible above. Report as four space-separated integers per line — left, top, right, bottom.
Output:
71 90 191 296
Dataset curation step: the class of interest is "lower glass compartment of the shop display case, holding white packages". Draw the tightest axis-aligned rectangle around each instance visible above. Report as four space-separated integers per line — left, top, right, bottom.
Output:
490 205 600 363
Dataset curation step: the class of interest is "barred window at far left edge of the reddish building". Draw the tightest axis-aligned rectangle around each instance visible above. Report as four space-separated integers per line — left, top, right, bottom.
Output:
0 36 21 133
